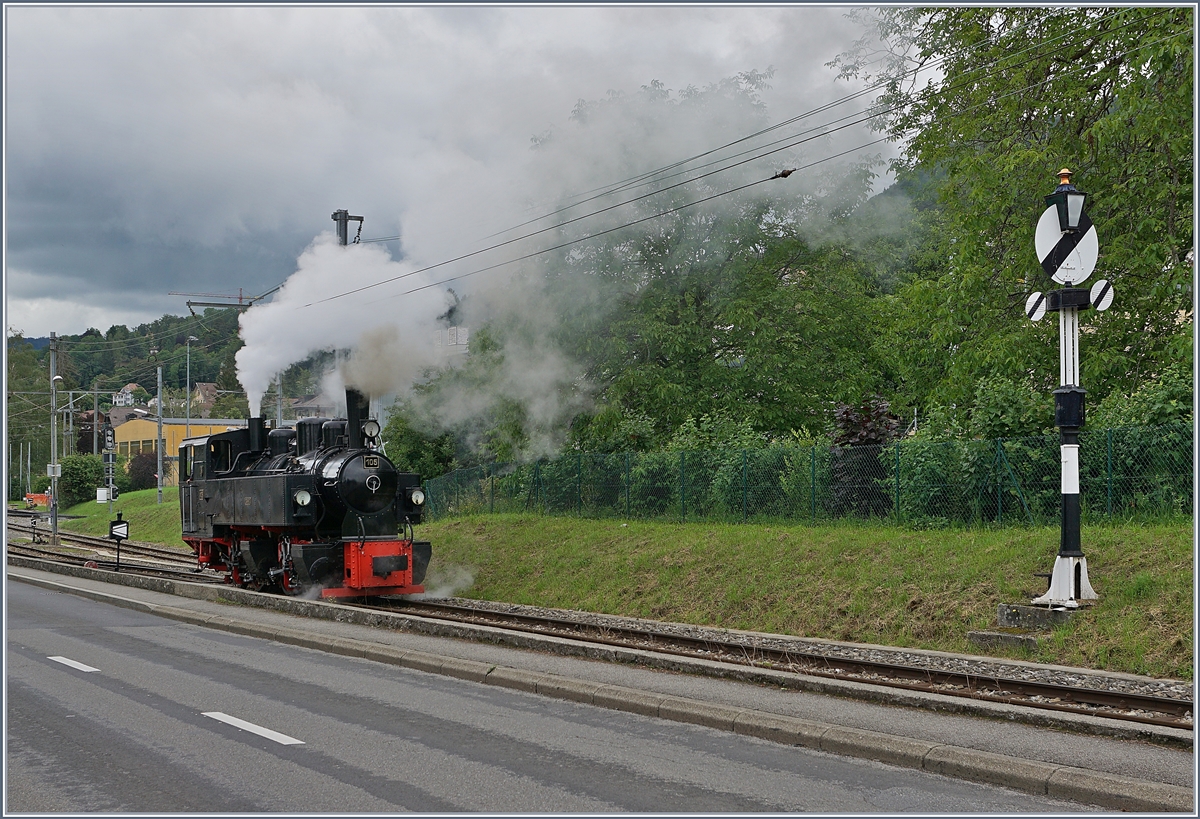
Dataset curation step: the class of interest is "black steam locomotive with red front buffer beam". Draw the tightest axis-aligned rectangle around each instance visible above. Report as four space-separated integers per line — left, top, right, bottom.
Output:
179 389 432 597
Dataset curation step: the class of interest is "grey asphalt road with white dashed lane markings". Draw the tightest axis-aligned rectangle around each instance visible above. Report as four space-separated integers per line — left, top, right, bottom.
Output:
5 582 1087 813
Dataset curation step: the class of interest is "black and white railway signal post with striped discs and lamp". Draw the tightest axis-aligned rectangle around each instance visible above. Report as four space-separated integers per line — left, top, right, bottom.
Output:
1025 168 1112 608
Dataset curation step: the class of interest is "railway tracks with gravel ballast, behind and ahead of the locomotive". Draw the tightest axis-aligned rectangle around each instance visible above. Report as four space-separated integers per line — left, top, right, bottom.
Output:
8 524 1193 730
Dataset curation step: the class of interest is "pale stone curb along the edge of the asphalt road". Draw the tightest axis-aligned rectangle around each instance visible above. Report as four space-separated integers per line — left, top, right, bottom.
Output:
8 557 1194 813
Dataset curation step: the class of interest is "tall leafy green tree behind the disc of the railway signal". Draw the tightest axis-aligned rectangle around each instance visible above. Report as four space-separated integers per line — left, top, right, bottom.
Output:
835 6 1194 405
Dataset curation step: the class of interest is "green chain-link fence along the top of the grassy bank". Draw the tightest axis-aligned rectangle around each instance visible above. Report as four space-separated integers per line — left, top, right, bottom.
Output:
425 424 1194 525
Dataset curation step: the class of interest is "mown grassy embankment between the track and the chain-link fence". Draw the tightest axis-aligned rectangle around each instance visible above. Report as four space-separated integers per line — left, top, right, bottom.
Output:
42 490 1193 680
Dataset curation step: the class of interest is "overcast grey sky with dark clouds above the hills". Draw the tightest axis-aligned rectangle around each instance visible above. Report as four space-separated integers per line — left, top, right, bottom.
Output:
5 5 878 336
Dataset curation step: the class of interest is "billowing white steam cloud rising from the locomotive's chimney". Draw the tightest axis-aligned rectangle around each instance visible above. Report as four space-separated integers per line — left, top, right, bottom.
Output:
236 65 878 446
